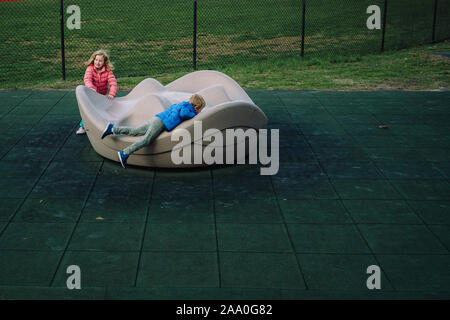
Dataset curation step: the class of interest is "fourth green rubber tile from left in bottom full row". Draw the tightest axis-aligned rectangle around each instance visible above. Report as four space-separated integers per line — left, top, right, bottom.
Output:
220 252 306 289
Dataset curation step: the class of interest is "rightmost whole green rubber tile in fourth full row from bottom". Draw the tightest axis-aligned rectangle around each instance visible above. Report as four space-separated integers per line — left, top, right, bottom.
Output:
332 179 402 199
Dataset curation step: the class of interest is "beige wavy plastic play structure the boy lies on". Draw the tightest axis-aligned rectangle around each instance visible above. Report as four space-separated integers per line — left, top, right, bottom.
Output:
76 70 267 168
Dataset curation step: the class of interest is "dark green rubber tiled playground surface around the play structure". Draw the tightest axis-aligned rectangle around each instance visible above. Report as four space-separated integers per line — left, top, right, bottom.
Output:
0 91 450 299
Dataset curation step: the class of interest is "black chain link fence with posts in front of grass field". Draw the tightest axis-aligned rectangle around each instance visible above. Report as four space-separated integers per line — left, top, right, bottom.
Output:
0 0 450 87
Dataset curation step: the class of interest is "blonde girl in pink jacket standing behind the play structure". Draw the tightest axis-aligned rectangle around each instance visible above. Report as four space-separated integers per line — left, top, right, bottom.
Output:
77 50 117 134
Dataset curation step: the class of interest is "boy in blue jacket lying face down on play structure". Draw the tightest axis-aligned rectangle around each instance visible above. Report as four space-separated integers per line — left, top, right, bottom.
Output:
101 94 206 168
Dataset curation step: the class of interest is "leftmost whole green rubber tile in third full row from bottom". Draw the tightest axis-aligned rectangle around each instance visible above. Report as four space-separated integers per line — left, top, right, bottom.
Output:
14 198 84 222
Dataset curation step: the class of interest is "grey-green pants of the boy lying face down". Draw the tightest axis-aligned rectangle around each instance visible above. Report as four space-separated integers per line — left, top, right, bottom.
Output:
113 117 165 155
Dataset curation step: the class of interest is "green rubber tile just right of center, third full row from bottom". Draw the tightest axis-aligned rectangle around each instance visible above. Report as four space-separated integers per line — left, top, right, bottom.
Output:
214 198 282 223
